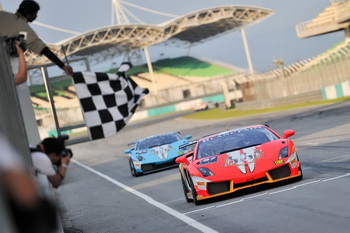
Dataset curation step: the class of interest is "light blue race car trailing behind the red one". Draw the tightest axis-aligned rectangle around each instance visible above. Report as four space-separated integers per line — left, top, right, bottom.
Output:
124 132 192 176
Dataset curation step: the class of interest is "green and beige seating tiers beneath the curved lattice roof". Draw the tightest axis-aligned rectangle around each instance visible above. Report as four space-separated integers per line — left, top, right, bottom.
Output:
29 57 242 109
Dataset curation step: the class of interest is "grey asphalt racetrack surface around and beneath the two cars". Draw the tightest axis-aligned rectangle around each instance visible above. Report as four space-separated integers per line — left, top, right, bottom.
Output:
55 101 350 233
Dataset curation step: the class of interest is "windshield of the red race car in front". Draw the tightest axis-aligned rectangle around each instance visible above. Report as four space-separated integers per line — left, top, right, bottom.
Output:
197 126 278 159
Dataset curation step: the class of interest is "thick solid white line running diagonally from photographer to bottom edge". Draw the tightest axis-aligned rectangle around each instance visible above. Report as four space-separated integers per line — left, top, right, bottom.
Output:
72 159 217 233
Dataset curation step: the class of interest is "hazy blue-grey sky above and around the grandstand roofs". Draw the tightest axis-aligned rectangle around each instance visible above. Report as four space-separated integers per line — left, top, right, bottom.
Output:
0 0 345 73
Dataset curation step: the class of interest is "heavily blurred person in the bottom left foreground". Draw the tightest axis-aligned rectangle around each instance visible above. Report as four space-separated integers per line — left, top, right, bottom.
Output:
0 132 58 233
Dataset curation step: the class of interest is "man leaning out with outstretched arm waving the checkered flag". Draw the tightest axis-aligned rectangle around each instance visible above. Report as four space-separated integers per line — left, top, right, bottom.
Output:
0 0 73 75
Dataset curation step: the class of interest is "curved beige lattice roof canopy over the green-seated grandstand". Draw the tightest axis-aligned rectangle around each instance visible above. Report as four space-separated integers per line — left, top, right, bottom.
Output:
26 6 274 65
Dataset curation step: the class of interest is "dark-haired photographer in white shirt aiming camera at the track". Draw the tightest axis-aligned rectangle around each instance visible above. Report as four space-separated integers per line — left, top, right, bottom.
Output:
31 137 73 188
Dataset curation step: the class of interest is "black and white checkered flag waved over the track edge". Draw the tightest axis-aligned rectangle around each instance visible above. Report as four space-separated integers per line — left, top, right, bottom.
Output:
73 63 148 140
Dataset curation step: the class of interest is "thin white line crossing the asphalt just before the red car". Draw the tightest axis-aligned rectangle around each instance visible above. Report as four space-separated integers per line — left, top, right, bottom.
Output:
184 173 350 215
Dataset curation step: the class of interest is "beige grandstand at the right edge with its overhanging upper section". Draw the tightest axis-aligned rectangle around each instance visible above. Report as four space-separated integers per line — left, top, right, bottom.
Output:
242 0 350 105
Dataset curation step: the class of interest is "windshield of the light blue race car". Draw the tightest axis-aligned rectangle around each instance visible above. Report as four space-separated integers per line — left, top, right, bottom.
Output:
136 133 183 150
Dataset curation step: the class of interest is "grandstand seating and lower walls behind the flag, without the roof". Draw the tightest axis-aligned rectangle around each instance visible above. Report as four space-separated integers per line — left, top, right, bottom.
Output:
29 56 244 137
